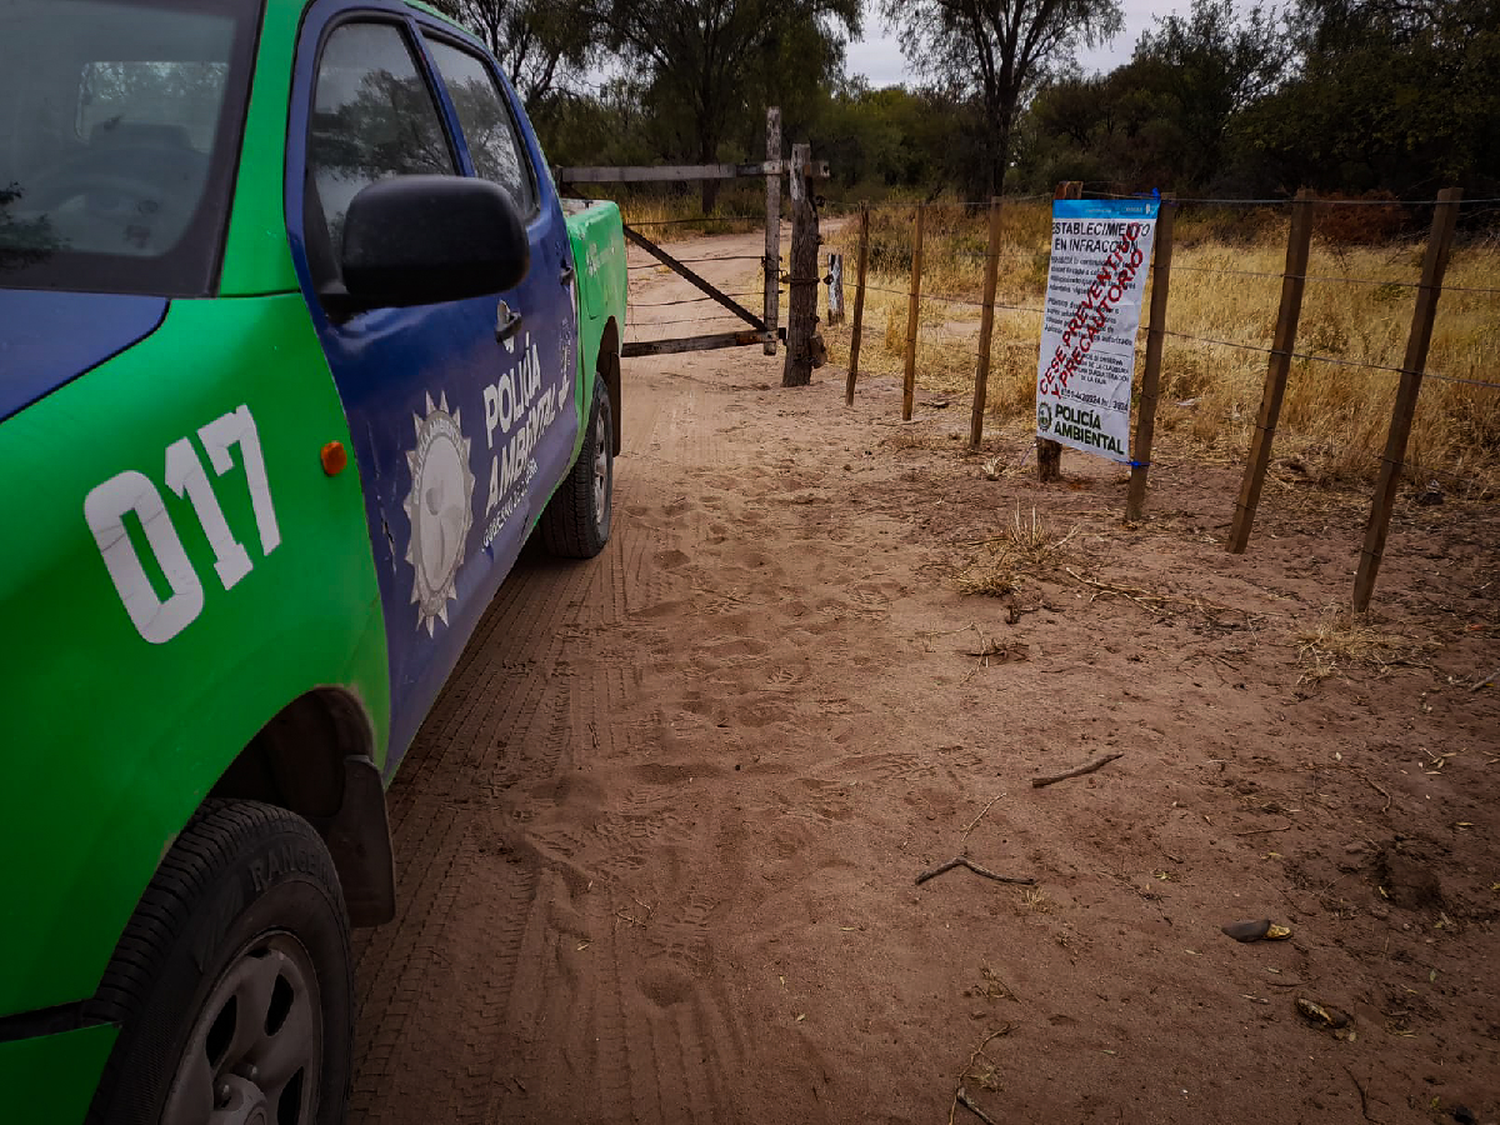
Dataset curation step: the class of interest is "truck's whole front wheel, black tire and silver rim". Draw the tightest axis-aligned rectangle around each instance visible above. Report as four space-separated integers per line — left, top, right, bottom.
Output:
89 801 354 1125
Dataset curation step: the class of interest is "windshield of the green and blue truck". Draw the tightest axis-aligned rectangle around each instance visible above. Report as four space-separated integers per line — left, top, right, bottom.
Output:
0 0 260 297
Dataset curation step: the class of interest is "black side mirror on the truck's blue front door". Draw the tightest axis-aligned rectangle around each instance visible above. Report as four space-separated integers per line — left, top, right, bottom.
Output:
336 176 531 314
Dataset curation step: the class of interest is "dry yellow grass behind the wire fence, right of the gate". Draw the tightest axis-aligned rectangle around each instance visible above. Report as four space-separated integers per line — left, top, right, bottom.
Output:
825 201 1500 495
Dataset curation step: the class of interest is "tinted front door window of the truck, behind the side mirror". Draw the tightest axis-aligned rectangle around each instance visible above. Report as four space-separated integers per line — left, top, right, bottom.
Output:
308 24 458 248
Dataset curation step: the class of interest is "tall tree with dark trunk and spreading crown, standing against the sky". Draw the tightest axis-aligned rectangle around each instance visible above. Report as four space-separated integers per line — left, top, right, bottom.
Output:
881 0 1121 194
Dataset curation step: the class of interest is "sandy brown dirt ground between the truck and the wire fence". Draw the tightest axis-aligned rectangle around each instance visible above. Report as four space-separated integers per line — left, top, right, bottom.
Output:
351 229 1500 1125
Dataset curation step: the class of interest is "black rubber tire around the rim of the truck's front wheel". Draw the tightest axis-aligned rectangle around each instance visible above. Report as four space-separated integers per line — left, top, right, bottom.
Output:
87 800 354 1125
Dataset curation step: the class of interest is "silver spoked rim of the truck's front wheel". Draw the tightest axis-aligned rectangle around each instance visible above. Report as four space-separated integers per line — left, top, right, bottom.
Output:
162 933 323 1125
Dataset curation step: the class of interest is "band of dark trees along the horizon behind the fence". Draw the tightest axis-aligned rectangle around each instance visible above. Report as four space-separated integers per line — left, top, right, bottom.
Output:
440 0 1500 207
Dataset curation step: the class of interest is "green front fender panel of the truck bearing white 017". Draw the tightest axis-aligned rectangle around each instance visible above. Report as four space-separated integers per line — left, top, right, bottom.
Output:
0 294 389 1016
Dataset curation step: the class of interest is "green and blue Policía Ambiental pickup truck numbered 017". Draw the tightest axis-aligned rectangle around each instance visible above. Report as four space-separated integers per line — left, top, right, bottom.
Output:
0 0 626 1125
